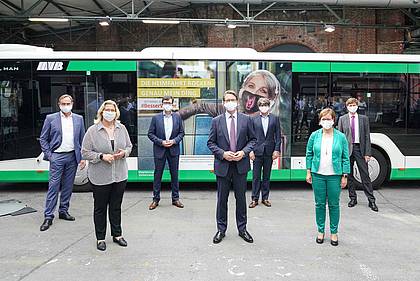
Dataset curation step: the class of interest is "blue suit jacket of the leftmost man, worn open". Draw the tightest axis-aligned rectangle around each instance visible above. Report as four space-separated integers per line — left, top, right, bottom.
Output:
39 112 85 163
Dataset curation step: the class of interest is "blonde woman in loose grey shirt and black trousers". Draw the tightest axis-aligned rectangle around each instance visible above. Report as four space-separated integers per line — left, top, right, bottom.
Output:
82 100 133 251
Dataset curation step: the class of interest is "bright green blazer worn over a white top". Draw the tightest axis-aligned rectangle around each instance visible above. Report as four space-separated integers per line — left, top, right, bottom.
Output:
306 129 350 175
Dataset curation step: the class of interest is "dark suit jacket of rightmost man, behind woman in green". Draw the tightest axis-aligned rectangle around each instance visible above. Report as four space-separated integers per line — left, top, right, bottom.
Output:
338 114 372 156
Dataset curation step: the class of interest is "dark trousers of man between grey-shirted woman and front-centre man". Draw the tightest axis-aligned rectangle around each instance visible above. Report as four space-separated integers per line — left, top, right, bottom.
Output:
153 148 179 202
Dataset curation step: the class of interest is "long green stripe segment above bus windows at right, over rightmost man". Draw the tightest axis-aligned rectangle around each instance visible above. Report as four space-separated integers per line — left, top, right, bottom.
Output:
331 62 407 73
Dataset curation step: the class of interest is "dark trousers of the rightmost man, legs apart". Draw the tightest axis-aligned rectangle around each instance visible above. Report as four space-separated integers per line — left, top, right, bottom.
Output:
348 145 375 202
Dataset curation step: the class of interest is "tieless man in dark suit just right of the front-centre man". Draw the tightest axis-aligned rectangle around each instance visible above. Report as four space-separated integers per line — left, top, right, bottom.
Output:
249 98 281 208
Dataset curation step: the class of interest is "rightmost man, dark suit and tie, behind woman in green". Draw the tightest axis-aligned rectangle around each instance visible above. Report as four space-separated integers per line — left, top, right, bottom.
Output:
338 98 378 212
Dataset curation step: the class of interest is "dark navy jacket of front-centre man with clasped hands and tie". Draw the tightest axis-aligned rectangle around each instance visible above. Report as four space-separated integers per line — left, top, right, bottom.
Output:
207 112 257 177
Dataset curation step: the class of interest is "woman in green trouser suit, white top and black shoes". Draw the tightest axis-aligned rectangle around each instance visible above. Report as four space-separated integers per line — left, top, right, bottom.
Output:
306 108 350 246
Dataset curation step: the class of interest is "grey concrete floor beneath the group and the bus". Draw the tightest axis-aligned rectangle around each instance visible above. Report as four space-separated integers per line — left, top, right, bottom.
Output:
0 182 420 281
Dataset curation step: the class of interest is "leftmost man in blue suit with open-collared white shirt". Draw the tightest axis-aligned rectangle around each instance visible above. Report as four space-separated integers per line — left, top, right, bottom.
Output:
39 94 85 231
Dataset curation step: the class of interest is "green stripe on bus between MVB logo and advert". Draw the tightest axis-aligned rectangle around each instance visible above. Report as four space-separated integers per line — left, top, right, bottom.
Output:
67 60 137 71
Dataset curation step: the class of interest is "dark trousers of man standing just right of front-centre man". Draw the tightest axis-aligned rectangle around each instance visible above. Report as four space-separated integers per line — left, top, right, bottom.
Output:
252 155 273 201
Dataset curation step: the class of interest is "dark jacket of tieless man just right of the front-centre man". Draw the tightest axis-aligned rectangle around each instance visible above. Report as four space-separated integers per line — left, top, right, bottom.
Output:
252 114 281 156
